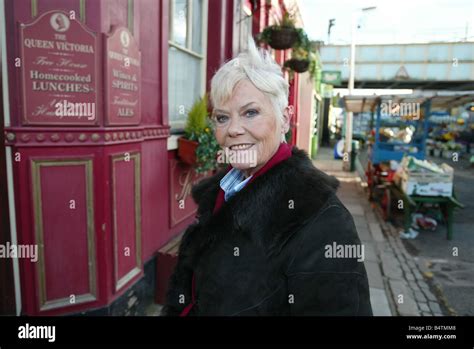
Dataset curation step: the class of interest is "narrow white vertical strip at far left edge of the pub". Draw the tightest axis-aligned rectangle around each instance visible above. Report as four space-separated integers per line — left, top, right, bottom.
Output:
0 0 21 315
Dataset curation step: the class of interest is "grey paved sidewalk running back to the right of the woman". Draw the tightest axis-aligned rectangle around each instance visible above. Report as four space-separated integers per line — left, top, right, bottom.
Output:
314 148 449 316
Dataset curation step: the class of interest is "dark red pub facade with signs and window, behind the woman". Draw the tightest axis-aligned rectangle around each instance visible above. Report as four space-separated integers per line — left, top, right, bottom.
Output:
0 0 312 315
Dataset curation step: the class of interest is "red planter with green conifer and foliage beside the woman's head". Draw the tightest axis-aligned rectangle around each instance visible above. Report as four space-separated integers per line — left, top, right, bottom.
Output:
178 95 220 173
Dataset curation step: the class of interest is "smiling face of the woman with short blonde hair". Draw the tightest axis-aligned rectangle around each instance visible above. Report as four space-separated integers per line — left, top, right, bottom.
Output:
213 80 289 176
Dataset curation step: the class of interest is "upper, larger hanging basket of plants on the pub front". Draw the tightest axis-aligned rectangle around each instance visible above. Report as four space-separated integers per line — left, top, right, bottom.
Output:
259 13 298 50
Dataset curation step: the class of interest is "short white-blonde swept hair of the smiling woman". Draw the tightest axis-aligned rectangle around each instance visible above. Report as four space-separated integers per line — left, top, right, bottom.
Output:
210 37 289 122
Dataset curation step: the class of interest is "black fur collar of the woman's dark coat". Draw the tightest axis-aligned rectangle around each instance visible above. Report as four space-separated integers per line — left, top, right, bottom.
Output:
187 148 339 256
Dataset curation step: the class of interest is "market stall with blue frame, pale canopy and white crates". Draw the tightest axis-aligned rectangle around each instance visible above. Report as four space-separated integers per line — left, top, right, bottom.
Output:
343 91 474 239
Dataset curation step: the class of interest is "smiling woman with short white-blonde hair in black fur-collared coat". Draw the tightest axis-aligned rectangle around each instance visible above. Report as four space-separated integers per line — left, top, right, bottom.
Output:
162 41 372 316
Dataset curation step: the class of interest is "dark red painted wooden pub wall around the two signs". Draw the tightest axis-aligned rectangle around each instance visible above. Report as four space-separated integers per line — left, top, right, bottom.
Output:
6 0 174 315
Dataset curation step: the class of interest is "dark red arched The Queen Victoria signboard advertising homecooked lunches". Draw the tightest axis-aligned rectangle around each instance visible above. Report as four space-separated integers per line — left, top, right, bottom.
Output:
20 11 100 125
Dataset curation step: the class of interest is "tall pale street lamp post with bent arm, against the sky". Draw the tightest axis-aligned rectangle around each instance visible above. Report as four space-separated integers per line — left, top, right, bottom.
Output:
342 6 377 171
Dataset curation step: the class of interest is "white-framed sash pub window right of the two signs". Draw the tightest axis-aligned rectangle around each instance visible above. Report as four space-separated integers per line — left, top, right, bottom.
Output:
168 0 207 132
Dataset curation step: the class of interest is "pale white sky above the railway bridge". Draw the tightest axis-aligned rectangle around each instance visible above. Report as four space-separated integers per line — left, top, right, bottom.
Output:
298 0 474 45
